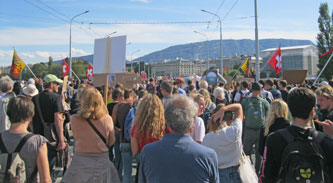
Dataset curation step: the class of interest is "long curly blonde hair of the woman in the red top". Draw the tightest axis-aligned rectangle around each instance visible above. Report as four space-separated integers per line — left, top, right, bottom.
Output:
134 93 165 139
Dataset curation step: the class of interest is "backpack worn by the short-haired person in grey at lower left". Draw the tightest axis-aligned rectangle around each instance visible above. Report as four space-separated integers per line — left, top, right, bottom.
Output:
0 134 37 183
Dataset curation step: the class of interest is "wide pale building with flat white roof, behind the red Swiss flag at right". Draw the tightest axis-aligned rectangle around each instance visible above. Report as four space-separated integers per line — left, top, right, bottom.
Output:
261 45 319 77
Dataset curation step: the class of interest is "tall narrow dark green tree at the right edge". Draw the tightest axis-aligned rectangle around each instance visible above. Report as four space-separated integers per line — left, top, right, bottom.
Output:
317 3 333 79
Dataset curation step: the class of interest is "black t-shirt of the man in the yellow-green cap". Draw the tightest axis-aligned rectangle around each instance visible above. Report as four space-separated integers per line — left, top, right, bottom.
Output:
32 90 64 135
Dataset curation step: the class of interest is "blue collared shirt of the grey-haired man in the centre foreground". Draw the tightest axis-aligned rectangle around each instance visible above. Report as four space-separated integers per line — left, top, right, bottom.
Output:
139 133 219 183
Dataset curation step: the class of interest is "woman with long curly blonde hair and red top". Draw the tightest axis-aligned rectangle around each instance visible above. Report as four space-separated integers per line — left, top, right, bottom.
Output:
131 94 165 181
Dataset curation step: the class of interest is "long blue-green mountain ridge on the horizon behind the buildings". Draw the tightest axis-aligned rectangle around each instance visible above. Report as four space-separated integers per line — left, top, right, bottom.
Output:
55 39 315 64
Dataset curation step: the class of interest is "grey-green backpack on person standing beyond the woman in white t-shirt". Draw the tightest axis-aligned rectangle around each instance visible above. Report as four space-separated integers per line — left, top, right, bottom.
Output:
242 97 268 128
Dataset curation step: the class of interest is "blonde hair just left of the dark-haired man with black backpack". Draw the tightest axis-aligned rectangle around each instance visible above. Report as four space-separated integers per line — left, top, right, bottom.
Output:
264 99 288 136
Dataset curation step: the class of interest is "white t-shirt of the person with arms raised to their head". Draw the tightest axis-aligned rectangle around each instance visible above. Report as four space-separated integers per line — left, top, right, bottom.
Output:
202 118 243 168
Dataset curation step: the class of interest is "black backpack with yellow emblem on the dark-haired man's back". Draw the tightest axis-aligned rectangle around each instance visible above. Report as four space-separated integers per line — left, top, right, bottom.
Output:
277 128 330 183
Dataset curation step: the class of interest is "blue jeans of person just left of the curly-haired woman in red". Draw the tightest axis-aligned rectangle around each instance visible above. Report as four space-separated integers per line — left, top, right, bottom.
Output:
120 143 132 183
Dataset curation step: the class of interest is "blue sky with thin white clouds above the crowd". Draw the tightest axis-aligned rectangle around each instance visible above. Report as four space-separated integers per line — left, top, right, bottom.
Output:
0 0 333 66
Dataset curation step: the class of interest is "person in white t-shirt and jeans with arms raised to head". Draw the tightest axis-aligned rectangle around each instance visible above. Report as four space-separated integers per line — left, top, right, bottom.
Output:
203 104 243 183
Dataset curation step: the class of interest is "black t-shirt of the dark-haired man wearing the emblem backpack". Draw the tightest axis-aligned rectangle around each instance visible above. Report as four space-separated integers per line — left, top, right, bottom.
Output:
260 126 333 183
